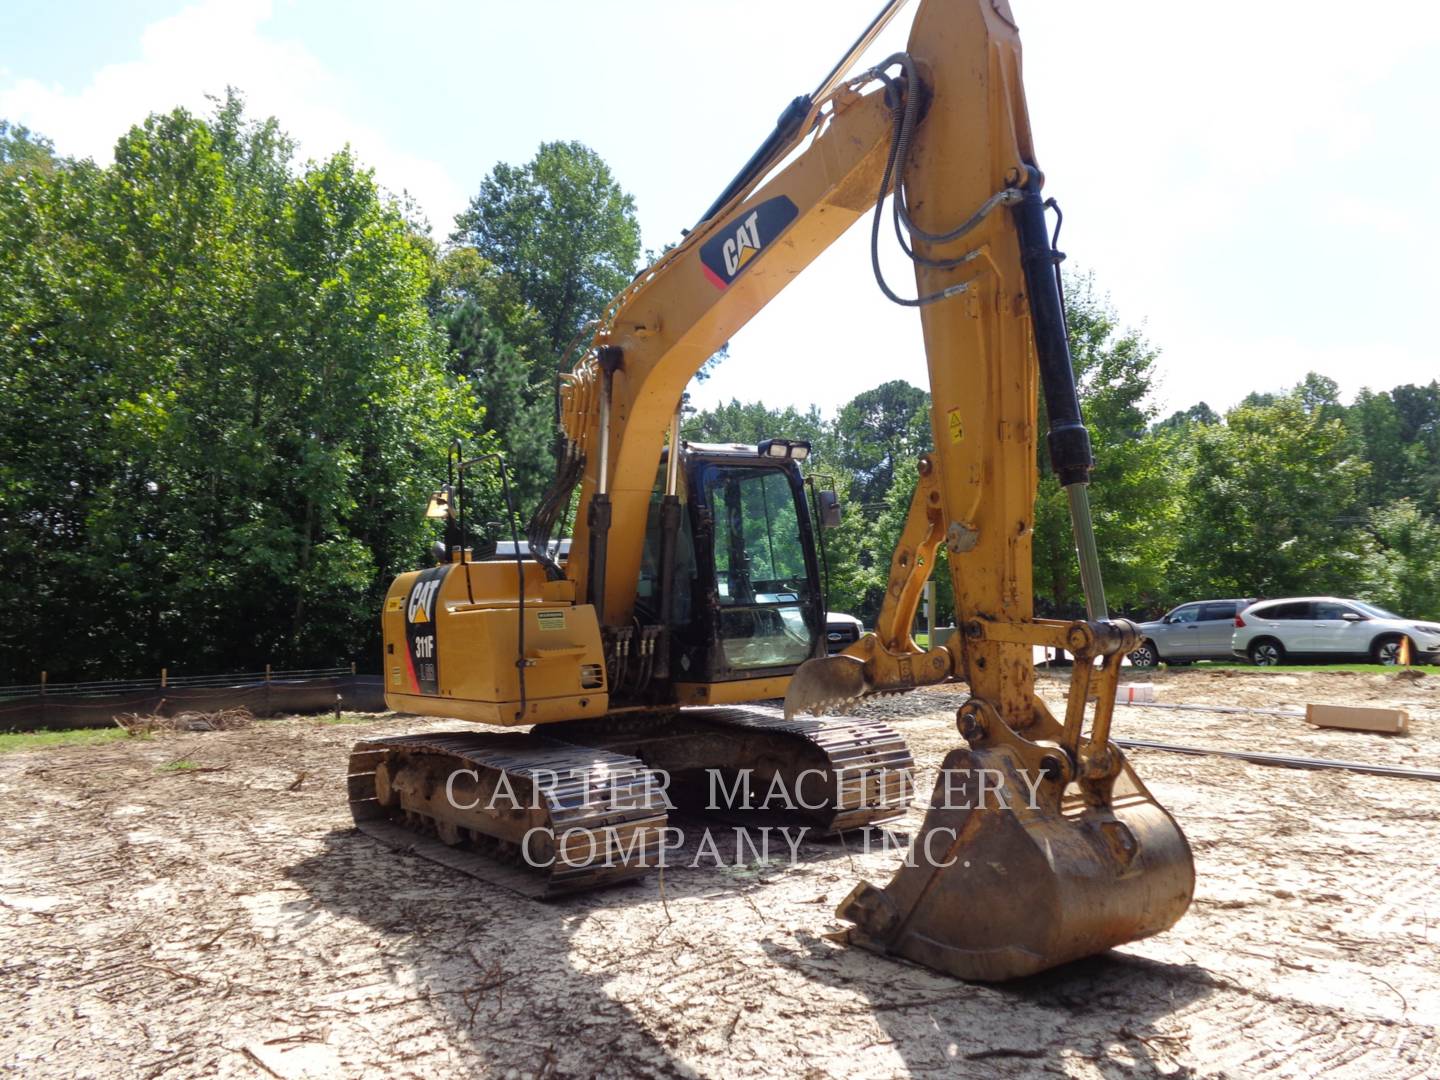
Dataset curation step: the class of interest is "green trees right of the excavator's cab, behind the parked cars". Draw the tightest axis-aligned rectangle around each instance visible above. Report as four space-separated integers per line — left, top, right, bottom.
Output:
687 285 1440 625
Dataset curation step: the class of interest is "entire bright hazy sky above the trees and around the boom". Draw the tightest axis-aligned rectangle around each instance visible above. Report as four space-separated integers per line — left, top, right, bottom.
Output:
0 0 1440 412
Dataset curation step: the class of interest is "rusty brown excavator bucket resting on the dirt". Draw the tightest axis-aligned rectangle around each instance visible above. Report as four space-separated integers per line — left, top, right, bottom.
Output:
838 696 1195 982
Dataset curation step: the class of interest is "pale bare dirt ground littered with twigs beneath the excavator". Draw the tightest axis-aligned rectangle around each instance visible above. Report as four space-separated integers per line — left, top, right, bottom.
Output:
0 671 1440 1079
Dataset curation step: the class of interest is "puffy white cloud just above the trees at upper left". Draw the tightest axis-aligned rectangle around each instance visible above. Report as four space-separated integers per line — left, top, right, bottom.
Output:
0 0 465 235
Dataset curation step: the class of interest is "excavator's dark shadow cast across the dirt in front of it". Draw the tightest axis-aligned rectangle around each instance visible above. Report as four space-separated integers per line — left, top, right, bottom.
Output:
288 829 1212 1077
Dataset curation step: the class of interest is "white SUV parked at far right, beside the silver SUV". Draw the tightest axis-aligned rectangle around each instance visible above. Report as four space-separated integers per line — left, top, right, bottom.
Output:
1230 596 1440 665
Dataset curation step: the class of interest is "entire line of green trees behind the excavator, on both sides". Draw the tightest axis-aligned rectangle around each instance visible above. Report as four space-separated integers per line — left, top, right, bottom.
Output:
0 99 1440 683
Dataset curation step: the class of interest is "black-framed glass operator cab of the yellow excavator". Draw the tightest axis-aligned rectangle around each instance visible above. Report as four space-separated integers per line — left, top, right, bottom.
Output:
636 439 829 683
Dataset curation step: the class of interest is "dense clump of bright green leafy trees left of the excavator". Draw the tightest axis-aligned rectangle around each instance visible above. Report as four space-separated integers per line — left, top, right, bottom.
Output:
0 94 477 678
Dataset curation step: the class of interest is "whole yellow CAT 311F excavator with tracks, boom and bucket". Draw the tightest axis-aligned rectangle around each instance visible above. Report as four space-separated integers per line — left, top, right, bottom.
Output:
348 0 1194 981
